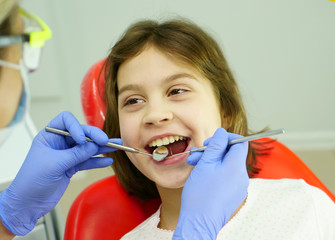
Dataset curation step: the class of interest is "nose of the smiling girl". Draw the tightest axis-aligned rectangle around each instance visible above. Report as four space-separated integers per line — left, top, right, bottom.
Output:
143 104 173 126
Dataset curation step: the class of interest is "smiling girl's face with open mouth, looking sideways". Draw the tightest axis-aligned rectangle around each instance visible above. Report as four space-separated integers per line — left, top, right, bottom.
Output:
117 46 221 188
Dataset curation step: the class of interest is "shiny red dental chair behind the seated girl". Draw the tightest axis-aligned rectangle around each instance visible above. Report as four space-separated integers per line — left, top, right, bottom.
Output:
64 60 335 240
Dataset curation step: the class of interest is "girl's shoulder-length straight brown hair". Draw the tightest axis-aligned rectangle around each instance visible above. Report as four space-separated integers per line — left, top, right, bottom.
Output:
103 19 257 202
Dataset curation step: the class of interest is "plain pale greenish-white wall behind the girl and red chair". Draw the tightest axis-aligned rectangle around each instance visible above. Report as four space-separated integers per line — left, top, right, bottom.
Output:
22 0 335 150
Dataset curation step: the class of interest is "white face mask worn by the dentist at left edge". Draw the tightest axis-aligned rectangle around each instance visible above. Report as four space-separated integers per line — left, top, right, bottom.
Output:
0 60 30 147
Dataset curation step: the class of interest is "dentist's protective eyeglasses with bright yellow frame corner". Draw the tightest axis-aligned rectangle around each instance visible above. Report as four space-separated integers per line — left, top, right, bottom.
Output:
0 8 51 71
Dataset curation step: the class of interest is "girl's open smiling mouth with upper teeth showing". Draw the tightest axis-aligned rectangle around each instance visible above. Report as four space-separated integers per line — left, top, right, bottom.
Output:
145 136 190 157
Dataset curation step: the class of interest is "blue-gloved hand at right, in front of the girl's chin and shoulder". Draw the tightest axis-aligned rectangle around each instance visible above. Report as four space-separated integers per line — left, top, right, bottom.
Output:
173 128 249 240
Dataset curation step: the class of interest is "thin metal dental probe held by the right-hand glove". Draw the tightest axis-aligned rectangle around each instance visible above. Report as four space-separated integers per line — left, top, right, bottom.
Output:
168 128 285 158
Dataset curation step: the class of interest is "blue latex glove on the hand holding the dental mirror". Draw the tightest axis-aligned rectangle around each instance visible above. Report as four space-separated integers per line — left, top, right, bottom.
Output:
0 112 122 236
